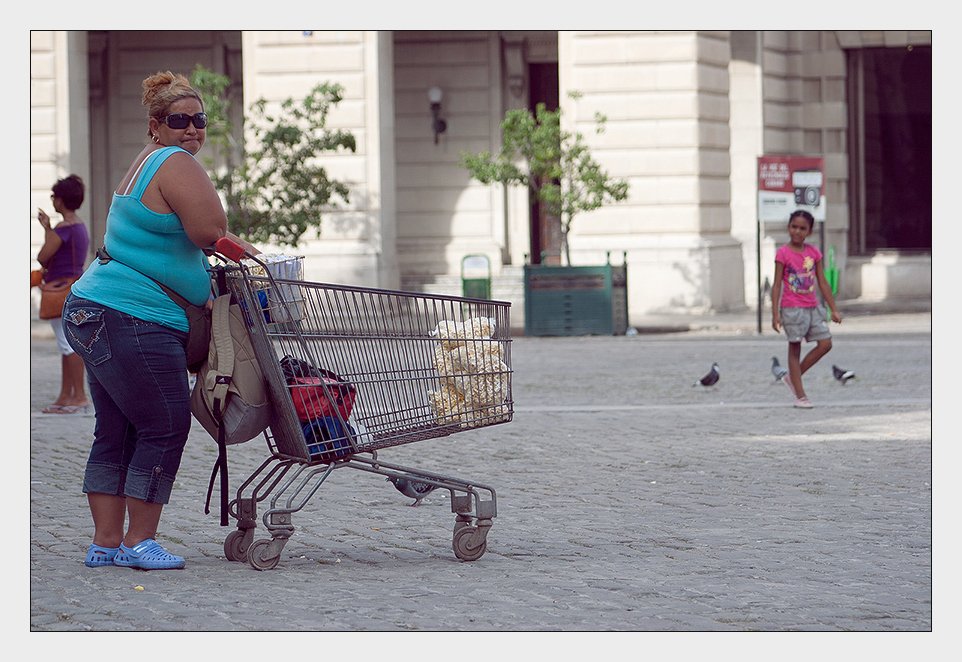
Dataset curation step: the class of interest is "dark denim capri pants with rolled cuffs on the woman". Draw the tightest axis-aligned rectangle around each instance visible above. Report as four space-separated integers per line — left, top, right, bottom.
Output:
62 294 191 504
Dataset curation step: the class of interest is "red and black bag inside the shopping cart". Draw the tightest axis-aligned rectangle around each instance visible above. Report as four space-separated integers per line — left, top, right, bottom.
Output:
281 356 357 423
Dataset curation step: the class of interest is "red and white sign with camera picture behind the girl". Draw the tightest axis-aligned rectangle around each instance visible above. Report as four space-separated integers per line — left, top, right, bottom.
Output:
758 156 826 223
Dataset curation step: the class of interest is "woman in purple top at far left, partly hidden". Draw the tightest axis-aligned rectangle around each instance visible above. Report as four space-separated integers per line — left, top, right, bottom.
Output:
37 175 90 414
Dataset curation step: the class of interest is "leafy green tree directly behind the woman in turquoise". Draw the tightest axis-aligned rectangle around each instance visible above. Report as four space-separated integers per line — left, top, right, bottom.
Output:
191 66 357 246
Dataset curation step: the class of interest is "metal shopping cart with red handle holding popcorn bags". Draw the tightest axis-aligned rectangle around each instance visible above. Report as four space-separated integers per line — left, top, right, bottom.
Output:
207 239 513 570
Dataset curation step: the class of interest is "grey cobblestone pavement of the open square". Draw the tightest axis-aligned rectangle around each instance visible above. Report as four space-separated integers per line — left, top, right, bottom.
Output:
29 314 933 644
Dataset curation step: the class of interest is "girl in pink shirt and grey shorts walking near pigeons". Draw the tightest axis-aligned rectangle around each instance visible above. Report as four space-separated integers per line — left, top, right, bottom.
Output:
772 209 842 409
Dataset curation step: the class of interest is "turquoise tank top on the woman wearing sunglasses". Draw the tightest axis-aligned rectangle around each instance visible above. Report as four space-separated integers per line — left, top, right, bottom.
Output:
72 147 211 331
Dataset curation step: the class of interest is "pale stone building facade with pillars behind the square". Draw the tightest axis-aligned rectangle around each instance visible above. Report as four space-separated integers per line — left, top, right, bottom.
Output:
30 30 932 325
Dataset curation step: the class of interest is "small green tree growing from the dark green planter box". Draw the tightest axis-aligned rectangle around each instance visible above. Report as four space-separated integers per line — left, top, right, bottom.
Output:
461 100 628 265
